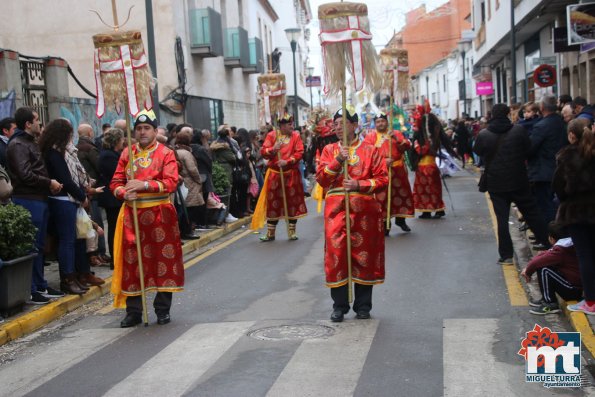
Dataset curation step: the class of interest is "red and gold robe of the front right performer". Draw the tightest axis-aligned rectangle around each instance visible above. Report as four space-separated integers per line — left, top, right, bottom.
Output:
316 141 388 288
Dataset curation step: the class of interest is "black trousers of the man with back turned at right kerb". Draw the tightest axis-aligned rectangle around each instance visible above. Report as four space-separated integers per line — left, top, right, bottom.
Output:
489 185 550 259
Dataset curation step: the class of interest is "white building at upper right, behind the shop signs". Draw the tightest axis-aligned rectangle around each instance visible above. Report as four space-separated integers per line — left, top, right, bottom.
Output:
471 0 576 109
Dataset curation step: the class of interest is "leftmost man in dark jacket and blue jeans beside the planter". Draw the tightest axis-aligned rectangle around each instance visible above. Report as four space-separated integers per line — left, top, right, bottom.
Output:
6 107 64 305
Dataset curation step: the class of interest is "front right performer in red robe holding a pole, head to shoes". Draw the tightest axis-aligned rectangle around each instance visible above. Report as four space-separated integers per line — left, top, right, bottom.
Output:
316 110 388 322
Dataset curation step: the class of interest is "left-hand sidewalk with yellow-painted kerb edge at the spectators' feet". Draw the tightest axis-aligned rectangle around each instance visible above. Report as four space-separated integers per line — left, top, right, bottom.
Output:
0 217 252 346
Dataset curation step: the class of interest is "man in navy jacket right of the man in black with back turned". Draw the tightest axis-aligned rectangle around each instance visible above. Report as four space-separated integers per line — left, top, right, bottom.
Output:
527 95 568 224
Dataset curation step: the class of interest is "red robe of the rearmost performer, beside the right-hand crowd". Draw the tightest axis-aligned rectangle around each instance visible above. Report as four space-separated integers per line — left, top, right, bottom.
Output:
413 141 445 212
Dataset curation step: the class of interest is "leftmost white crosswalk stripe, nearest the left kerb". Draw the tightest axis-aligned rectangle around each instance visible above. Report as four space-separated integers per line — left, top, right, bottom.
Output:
0 319 133 397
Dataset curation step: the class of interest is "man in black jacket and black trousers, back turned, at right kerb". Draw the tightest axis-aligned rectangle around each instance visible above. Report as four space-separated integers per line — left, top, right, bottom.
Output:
473 104 549 264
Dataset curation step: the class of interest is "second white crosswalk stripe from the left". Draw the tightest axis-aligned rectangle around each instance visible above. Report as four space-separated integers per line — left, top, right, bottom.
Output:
105 322 254 397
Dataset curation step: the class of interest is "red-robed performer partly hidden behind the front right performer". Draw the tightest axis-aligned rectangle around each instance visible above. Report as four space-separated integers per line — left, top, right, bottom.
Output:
365 112 414 235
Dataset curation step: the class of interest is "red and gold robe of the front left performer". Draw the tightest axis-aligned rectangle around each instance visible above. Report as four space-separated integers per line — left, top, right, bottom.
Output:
110 142 184 307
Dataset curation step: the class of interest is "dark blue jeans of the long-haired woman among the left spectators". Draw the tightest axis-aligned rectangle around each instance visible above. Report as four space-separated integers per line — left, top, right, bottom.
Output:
49 199 78 279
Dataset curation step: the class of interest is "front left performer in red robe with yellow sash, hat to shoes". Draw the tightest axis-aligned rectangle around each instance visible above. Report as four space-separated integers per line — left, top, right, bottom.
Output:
110 111 184 328
